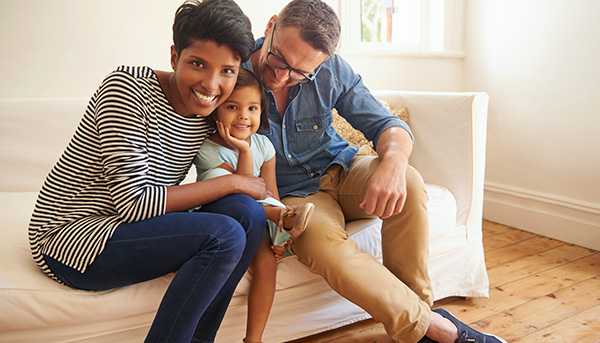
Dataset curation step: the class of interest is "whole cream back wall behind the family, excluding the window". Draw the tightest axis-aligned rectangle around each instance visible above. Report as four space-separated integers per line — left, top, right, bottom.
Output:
0 0 462 99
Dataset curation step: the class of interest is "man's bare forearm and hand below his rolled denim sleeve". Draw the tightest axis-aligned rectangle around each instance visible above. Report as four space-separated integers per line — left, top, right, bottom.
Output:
360 127 413 219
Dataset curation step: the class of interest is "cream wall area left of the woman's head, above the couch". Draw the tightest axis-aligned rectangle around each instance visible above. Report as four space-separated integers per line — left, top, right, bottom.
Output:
0 0 176 98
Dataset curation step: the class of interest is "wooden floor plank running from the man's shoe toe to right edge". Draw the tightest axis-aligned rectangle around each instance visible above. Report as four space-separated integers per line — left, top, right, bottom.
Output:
473 276 600 342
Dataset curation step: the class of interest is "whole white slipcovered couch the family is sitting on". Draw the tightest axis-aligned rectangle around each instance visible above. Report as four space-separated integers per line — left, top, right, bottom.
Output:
0 91 488 343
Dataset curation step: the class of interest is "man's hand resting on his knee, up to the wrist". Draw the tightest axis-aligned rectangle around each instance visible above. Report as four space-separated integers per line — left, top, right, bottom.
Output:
360 161 408 219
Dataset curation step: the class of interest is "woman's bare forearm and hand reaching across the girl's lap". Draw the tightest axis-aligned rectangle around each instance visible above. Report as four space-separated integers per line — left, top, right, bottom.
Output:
166 174 267 212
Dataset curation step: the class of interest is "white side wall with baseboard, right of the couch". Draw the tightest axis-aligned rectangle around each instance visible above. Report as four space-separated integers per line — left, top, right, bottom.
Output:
464 0 600 249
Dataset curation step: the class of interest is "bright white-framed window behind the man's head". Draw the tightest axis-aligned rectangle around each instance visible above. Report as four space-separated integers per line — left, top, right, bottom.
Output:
326 0 464 57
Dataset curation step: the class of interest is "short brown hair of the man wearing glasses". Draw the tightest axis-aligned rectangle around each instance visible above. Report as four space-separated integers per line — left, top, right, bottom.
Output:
277 0 341 55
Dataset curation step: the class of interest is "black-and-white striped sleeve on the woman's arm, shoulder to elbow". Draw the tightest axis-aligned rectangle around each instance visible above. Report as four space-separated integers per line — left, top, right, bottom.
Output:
96 71 167 223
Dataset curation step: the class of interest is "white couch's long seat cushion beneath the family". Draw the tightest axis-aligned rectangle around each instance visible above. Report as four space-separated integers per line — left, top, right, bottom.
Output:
0 185 456 331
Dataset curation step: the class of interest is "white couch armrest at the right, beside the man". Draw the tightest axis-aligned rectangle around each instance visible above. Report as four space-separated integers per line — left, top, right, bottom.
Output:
374 90 489 242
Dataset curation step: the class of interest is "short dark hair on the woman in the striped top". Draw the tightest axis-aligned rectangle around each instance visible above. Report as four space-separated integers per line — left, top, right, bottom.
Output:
173 0 255 62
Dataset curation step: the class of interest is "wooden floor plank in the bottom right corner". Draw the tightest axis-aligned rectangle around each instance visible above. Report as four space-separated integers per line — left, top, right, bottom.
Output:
514 306 600 343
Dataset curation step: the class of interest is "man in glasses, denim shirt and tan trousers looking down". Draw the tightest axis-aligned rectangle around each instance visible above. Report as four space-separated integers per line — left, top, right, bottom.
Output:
247 0 500 343
